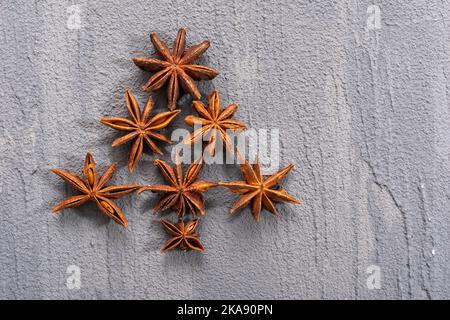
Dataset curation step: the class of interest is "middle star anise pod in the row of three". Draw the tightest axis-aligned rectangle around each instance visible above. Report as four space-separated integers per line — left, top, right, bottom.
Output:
138 158 217 217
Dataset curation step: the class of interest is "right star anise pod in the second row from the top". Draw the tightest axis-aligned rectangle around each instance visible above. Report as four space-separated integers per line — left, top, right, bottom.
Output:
184 90 247 155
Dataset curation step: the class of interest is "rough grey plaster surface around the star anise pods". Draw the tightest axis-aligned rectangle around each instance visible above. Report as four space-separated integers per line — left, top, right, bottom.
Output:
0 0 450 299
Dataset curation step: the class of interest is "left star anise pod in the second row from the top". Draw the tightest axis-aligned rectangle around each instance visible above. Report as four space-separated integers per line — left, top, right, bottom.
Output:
100 90 180 172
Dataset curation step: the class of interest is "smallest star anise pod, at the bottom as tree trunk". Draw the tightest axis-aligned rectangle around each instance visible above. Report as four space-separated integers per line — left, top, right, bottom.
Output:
161 218 205 252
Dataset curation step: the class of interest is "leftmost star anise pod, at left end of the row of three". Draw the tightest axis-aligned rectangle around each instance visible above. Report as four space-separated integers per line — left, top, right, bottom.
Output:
52 152 140 227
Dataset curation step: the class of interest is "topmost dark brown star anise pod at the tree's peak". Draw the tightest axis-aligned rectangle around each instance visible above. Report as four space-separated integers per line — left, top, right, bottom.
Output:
133 28 219 110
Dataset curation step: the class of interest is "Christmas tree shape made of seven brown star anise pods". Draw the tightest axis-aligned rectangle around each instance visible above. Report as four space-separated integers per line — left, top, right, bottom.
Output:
52 28 300 252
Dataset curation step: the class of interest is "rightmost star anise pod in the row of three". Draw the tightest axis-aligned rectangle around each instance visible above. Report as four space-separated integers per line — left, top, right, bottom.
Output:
219 161 300 222
